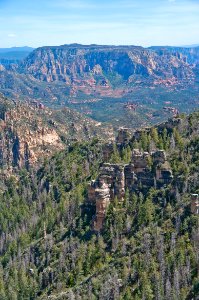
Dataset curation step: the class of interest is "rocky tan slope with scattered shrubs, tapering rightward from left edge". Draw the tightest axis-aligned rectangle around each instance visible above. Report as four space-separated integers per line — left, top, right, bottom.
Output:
0 96 113 171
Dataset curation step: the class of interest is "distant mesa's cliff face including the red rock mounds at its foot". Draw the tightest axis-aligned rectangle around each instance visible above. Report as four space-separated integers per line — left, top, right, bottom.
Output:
15 45 195 96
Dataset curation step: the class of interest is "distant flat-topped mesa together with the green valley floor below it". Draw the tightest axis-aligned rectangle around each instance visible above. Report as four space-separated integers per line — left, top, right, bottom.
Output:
0 44 199 128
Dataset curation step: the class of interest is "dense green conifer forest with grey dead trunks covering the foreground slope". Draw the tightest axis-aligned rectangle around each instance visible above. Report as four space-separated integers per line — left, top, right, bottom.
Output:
0 113 199 300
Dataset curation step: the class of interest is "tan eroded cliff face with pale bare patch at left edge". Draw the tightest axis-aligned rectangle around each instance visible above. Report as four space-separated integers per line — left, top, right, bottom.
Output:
0 105 64 171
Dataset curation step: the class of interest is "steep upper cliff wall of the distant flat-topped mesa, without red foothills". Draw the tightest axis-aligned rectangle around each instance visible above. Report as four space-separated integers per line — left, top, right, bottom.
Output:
20 44 196 86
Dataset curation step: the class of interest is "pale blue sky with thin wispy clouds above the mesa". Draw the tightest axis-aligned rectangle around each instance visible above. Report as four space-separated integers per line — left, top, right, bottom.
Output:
0 0 199 48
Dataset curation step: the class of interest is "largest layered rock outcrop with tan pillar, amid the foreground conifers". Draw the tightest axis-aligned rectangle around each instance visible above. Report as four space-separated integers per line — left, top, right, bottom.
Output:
88 149 173 231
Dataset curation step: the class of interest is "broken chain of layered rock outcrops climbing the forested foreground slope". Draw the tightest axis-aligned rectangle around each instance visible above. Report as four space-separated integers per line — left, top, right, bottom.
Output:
88 117 190 231
